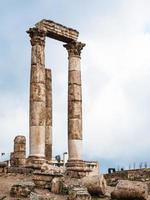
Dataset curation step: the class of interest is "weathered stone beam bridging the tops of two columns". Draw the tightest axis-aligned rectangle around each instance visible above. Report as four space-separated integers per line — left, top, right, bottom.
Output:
36 19 79 42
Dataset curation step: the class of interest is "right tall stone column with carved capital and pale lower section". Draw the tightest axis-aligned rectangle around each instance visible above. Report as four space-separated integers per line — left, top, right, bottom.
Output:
64 42 85 170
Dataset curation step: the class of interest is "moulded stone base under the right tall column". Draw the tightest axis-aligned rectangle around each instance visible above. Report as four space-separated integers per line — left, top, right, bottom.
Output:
66 160 91 178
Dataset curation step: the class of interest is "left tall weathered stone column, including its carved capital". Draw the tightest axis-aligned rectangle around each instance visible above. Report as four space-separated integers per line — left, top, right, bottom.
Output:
27 28 45 164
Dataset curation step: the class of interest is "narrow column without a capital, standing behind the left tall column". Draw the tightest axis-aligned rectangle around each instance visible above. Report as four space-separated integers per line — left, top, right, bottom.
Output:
45 69 52 160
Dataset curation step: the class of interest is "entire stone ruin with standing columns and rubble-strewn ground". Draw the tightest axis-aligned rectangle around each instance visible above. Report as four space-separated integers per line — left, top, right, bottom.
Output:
0 20 150 200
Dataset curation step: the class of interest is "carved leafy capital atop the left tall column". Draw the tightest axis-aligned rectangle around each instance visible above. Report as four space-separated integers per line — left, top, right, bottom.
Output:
27 28 46 46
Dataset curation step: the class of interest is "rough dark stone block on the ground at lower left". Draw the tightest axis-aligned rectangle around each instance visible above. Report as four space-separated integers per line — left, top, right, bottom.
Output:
10 182 35 197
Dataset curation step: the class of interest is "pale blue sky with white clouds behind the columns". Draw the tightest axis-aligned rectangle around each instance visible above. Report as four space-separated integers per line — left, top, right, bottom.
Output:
0 0 150 171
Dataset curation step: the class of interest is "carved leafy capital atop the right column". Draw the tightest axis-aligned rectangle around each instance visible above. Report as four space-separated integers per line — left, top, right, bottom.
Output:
63 41 85 57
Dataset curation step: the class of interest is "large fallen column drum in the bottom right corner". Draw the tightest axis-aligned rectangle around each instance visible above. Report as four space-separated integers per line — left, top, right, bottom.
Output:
111 180 148 200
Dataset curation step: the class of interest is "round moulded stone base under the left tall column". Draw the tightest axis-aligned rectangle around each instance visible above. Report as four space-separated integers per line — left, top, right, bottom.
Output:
26 156 46 169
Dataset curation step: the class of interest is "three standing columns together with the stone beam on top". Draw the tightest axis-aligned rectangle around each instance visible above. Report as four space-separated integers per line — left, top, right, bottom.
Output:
27 20 86 177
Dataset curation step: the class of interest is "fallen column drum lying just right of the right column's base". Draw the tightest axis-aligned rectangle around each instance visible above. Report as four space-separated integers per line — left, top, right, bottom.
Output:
82 175 107 196
